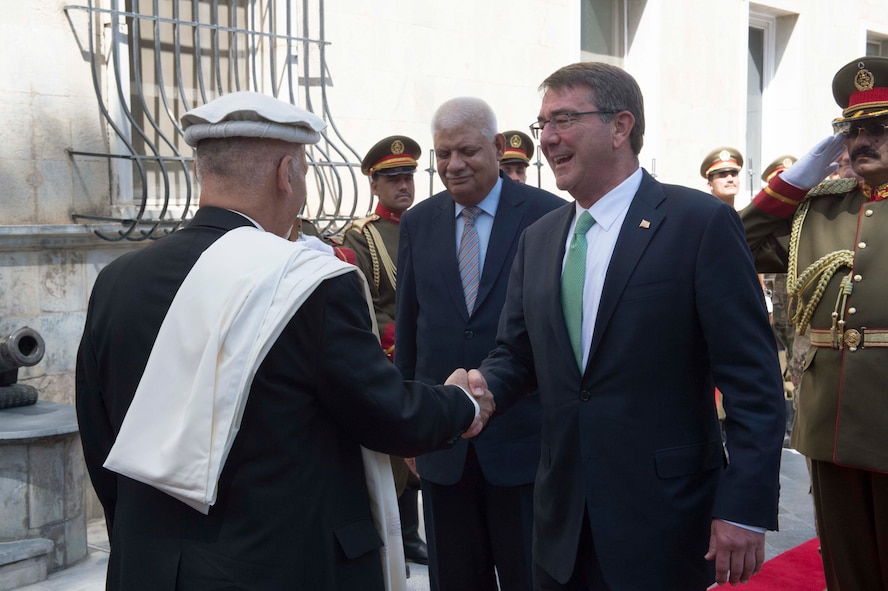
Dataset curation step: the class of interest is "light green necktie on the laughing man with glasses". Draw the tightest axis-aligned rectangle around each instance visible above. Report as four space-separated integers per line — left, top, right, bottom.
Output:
561 211 595 372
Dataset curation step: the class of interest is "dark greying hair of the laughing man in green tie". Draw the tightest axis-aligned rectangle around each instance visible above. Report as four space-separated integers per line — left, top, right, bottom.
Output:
540 62 644 156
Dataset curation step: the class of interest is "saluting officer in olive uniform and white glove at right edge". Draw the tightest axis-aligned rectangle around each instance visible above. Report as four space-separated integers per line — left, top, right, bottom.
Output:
742 57 888 591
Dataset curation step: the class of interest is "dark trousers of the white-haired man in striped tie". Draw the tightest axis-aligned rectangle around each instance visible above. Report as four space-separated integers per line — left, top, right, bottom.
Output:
420 445 533 591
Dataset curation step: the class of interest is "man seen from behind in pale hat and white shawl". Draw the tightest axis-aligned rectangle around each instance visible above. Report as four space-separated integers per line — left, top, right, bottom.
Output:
76 93 491 591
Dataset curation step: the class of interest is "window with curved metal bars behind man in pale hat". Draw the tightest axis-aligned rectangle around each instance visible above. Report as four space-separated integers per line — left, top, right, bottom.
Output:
68 0 360 240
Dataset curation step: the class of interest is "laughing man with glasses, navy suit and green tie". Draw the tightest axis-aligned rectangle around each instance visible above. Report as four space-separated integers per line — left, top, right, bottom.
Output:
469 62 784 591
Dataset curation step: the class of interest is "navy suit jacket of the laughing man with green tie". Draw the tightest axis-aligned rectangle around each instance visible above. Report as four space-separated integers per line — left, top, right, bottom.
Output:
482 173 785 591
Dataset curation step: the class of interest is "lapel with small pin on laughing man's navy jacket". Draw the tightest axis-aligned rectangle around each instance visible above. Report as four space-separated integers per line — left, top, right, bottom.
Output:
588 172 665 369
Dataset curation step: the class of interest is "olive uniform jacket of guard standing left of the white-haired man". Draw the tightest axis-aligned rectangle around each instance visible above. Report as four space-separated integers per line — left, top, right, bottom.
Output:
342 206 400 359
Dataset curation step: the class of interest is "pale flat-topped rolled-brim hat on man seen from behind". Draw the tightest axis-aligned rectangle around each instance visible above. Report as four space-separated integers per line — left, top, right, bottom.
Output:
182 92 327 147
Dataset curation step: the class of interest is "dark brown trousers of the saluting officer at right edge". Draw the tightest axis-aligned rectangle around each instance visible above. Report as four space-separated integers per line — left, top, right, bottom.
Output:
811 460 888 591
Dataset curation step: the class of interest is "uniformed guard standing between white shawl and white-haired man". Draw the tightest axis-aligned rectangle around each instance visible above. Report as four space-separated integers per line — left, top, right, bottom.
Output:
342 135 428 564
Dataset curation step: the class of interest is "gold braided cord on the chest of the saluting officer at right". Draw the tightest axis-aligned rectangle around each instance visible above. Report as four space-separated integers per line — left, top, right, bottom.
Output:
786 198 854 343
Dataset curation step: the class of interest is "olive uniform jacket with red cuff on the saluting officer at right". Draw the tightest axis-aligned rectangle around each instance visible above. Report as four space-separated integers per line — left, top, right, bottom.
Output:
742 177 888 472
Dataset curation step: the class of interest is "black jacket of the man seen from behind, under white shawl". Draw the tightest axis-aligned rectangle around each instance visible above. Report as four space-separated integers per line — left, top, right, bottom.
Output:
77 208 474 591
